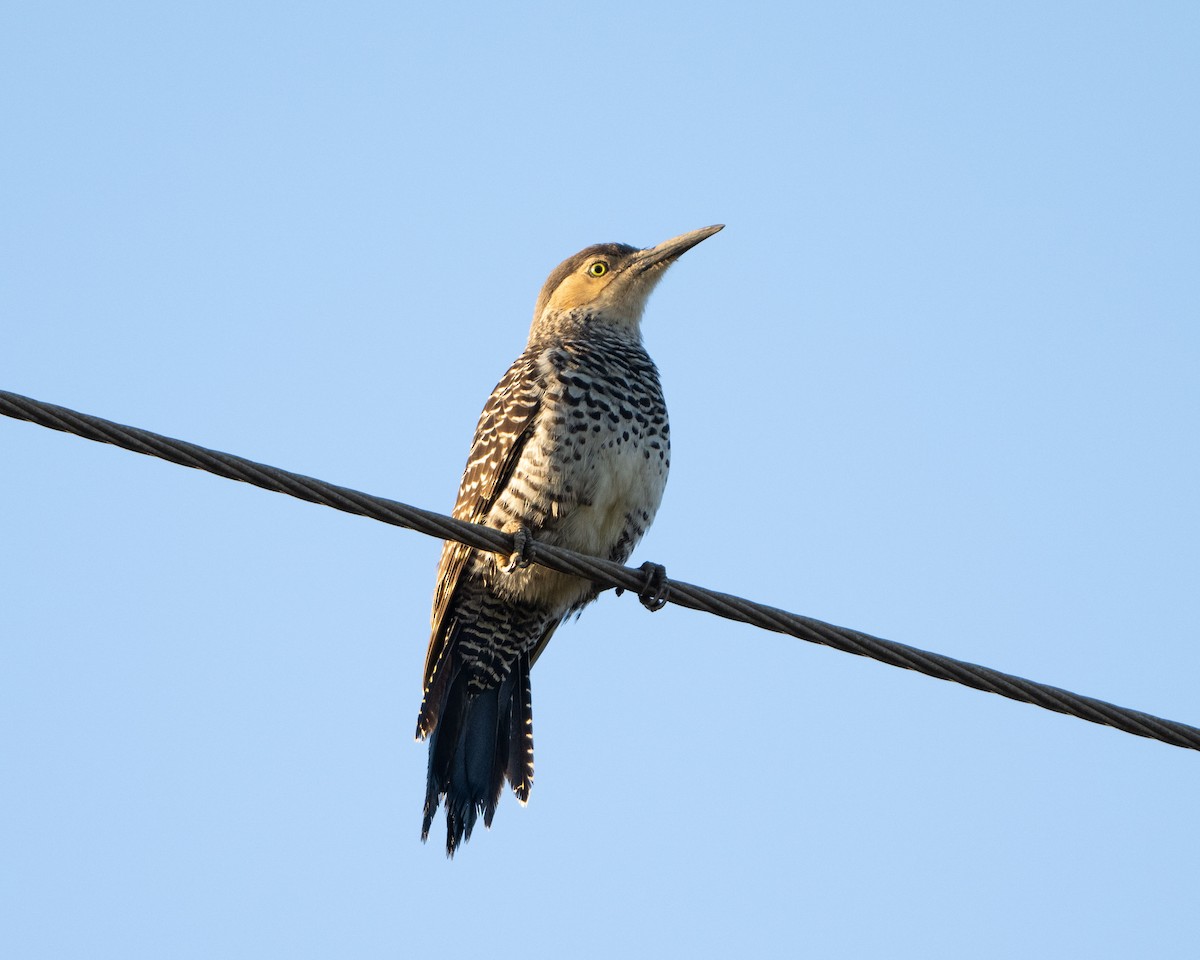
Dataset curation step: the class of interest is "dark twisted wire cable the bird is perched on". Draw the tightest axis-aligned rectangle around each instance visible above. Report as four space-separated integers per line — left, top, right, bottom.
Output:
0 390 1200 750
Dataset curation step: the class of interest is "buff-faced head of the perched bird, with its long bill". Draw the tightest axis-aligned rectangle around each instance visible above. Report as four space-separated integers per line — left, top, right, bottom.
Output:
533 224 724 336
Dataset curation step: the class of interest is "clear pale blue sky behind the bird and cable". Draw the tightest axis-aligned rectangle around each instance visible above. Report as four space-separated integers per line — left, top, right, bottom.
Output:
0 2 1200 960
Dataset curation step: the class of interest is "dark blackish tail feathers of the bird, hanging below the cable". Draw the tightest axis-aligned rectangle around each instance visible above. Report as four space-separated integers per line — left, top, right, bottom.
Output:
418 654 533 857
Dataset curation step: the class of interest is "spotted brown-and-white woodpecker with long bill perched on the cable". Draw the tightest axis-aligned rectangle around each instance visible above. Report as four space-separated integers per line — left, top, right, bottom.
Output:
416 224 724 858
